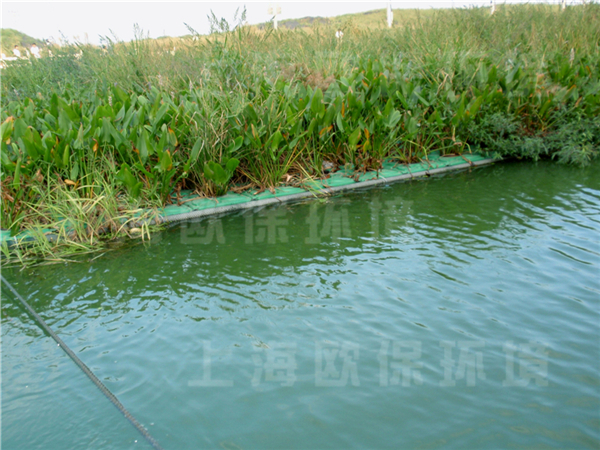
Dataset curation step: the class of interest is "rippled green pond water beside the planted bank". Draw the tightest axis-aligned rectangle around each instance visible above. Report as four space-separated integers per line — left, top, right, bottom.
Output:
1 162 600 450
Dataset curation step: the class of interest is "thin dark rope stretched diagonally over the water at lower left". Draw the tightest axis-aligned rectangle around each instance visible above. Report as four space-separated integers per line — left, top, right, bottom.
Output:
0 275 163 450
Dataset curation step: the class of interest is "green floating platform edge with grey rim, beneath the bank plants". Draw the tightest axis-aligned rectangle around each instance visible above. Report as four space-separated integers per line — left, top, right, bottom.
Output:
0 152 495 246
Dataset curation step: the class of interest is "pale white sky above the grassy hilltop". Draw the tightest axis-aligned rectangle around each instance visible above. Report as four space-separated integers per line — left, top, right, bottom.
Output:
2 0 573 45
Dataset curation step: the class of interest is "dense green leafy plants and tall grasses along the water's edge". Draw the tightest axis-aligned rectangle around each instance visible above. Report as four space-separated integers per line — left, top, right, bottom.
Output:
1 3 600 264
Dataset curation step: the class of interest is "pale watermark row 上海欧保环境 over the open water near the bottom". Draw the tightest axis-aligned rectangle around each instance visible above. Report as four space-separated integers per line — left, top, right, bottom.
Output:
188 340 549 387
